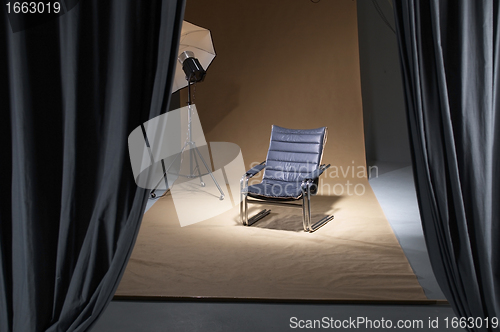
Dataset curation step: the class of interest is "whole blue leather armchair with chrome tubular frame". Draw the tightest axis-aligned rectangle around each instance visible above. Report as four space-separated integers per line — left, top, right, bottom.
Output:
240 126 333 232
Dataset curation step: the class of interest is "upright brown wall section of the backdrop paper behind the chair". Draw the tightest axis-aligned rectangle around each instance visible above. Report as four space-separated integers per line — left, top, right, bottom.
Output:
181 0 365 177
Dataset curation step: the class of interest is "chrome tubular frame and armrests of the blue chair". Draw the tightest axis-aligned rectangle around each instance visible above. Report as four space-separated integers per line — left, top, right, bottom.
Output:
240 161 334 233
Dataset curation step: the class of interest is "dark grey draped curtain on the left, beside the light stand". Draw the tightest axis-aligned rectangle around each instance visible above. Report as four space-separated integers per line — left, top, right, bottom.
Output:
0 0 184 332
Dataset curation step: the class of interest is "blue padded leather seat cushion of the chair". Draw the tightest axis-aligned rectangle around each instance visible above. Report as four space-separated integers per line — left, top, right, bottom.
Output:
248 180 302 199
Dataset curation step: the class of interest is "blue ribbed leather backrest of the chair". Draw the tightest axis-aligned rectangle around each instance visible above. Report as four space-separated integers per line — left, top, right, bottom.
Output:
263 125 327 182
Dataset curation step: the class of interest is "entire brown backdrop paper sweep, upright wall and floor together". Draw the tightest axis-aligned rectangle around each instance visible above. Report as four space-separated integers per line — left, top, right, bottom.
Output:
116 0 426 301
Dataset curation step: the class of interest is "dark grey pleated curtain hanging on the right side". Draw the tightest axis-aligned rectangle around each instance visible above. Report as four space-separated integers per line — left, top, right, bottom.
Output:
394 0 500 330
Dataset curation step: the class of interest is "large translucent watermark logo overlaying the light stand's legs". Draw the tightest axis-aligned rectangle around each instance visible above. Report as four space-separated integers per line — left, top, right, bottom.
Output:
128 105 245 226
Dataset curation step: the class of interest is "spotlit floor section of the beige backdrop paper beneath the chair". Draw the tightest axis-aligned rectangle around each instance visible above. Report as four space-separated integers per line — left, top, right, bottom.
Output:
115 179 428 303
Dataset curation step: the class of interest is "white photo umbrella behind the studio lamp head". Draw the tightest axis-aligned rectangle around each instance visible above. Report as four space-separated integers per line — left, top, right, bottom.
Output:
172 21 215 93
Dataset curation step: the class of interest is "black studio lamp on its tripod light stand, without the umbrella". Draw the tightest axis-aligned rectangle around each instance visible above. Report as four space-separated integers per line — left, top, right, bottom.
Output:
150 51 224 200
